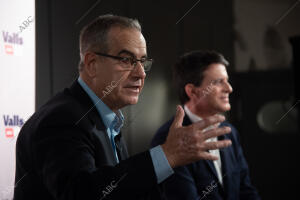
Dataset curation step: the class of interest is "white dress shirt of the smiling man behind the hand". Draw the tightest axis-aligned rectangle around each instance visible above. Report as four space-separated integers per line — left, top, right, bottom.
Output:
184 105 223 185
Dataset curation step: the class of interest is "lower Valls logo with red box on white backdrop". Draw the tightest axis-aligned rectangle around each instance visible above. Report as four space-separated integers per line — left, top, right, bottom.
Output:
3 115 25 138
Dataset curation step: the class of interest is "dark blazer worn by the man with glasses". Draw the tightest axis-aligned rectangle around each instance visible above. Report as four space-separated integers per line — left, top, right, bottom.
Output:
14 81 160 200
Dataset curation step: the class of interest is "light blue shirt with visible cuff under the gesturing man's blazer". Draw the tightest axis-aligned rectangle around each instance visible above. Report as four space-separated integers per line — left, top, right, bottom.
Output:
78 77 174 184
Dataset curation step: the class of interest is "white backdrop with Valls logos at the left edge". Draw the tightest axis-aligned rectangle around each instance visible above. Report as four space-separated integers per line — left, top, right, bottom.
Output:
0 0 35 200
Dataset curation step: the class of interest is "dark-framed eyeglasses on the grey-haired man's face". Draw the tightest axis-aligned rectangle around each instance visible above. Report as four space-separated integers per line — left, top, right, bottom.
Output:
94 52 153 72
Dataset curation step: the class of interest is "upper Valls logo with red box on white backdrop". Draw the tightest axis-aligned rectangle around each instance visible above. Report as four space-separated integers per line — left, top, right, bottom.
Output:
2 31 23 55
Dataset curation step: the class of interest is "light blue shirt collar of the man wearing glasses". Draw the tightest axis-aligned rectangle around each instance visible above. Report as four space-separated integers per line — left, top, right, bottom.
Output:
78 76 124 133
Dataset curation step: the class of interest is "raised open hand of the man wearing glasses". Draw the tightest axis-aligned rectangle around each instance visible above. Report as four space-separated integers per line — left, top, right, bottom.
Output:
161 106 231 168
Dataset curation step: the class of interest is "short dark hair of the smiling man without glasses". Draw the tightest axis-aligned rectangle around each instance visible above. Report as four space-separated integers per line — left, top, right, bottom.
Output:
173 50 229 104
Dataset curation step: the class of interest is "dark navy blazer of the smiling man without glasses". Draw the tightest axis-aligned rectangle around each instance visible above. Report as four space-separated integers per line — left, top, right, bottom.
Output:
151 115 260 200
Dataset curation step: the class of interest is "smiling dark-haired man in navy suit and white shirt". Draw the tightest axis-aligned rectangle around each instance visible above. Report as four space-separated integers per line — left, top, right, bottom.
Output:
152 51 260 200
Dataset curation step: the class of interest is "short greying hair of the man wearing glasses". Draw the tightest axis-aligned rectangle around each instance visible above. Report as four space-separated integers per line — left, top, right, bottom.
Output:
78 14 142 71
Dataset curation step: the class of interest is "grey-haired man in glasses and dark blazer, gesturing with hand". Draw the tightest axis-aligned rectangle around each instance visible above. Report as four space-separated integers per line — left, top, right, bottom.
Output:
14 15 231 200
